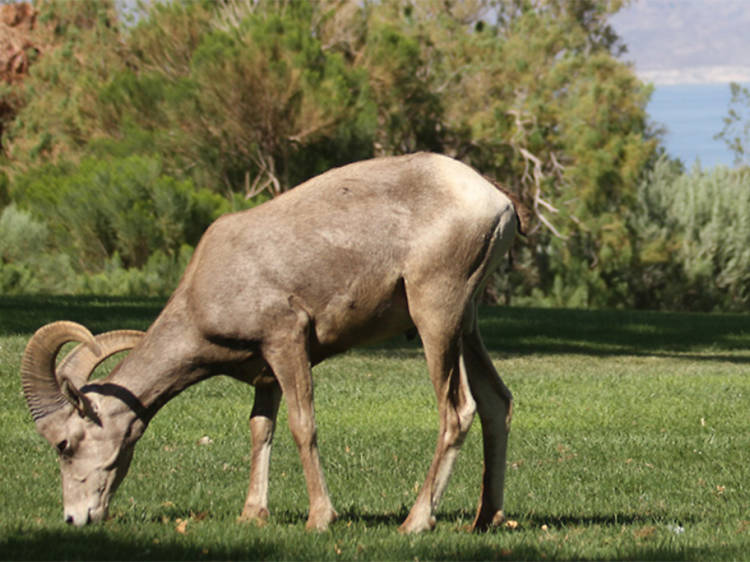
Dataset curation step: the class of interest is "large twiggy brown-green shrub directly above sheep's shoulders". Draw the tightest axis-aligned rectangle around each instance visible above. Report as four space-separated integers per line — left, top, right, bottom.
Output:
99 3 374 197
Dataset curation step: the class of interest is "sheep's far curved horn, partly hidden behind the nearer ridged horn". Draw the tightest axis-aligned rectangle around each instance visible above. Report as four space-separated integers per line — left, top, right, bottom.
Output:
57 330 145 388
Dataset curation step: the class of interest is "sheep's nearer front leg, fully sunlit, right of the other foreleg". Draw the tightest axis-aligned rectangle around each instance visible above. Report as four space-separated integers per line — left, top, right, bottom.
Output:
263 311 337 531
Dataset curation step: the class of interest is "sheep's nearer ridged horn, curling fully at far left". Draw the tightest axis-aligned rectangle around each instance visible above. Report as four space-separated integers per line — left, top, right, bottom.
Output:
21 321 101 421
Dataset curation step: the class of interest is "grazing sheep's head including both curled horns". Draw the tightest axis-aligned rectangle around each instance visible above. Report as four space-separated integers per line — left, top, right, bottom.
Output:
21 322 143 525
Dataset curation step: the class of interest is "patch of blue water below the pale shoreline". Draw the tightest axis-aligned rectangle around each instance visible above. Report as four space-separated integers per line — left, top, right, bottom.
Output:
647 84 748 170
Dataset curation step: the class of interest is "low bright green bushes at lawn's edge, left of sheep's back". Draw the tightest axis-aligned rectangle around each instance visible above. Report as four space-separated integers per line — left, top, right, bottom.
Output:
0 156 229 296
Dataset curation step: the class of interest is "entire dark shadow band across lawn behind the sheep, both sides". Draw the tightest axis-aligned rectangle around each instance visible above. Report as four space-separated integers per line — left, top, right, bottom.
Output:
0 296 750 363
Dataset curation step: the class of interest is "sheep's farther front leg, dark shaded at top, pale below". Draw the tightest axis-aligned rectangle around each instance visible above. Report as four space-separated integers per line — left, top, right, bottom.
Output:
240 382 281 523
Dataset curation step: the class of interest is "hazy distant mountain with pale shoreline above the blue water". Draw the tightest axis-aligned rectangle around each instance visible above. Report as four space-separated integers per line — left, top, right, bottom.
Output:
612 0 750 84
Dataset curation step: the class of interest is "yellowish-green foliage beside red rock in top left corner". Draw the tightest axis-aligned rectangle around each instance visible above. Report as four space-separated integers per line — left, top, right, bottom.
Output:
3 0 124 174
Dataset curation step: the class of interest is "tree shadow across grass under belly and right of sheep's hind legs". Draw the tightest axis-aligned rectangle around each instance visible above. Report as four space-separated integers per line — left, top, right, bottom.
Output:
368 307 750 364
